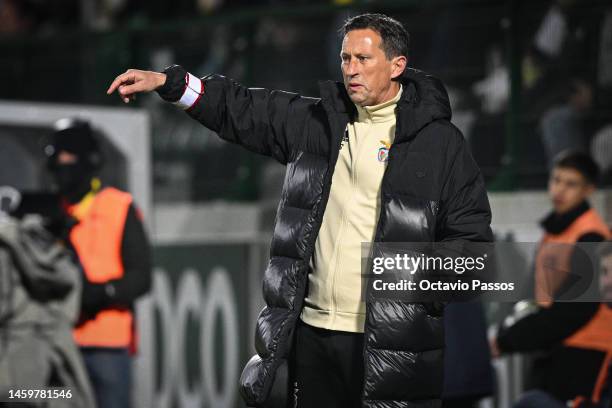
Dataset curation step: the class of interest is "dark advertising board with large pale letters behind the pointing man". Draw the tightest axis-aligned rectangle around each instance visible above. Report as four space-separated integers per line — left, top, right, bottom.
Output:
134 243 252 408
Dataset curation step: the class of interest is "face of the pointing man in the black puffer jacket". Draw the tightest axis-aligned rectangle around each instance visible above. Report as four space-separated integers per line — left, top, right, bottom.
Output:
340 28 406 106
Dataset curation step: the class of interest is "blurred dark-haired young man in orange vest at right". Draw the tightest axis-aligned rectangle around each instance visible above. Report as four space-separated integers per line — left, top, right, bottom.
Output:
492 151 612 408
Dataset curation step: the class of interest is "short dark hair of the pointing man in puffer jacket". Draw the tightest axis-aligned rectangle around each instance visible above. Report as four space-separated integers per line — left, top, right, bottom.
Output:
339 14 410 59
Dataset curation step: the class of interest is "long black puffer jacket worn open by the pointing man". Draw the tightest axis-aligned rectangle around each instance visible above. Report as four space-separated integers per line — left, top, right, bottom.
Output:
159 66 491 408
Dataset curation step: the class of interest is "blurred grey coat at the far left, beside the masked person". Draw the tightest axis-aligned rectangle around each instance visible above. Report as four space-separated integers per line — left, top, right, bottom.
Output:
0 218 95 408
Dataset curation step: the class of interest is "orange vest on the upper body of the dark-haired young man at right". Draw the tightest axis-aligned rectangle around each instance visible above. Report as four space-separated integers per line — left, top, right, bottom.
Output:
535 208 610 306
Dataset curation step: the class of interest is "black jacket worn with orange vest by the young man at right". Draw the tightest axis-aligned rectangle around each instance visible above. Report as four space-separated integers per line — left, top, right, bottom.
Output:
497 202 612 401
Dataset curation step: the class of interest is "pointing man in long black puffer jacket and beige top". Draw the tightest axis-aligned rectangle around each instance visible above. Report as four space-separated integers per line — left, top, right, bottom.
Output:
107 14 492 408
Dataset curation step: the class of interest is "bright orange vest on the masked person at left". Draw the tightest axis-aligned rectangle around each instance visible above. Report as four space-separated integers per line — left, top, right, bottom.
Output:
69 188 133 347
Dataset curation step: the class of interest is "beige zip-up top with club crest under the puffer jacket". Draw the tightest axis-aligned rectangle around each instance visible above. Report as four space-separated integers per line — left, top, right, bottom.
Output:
301 87 402 333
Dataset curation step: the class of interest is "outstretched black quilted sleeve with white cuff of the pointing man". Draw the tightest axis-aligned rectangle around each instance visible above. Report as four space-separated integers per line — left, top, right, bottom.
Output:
158 65 315 164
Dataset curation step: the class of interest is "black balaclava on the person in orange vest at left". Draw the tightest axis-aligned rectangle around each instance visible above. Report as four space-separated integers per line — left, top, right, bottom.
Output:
45 119 102 203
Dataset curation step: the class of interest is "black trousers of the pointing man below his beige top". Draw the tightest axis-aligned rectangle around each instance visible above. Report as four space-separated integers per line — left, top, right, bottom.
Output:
289 320 364 408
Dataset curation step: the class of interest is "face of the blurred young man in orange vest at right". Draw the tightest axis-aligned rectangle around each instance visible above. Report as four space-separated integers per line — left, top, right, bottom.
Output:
548 167 595 214
